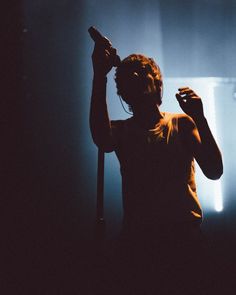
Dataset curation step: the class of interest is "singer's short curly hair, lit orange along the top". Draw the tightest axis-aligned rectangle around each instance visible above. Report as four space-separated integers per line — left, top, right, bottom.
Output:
115 54 162 109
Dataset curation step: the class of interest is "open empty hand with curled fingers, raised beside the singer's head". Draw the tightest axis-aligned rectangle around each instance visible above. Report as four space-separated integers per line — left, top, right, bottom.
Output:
175 87 204 119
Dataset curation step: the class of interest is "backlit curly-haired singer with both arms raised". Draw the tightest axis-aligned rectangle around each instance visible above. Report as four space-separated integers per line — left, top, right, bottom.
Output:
90 42 223 294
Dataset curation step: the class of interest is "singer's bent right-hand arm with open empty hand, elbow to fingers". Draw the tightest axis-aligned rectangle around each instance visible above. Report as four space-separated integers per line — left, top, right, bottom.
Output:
176 87 223 179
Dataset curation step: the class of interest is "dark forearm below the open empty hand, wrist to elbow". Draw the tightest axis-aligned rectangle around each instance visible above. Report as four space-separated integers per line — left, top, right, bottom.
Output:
194 116 223 179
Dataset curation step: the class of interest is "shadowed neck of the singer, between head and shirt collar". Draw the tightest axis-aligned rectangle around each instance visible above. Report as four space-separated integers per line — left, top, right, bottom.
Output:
133 106 163 129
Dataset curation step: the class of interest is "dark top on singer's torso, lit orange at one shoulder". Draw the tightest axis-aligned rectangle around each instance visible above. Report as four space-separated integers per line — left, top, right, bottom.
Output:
111 112 202 230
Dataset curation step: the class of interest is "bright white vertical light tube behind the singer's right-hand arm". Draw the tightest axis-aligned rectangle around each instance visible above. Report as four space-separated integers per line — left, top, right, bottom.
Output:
208 83 223 212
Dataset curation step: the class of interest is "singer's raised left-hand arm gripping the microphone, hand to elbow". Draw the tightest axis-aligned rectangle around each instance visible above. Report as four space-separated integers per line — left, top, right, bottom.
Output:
89 44 116 152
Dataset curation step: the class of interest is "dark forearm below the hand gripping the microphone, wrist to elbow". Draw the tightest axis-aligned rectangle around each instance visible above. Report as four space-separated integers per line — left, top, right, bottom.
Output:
90 75 112 151
